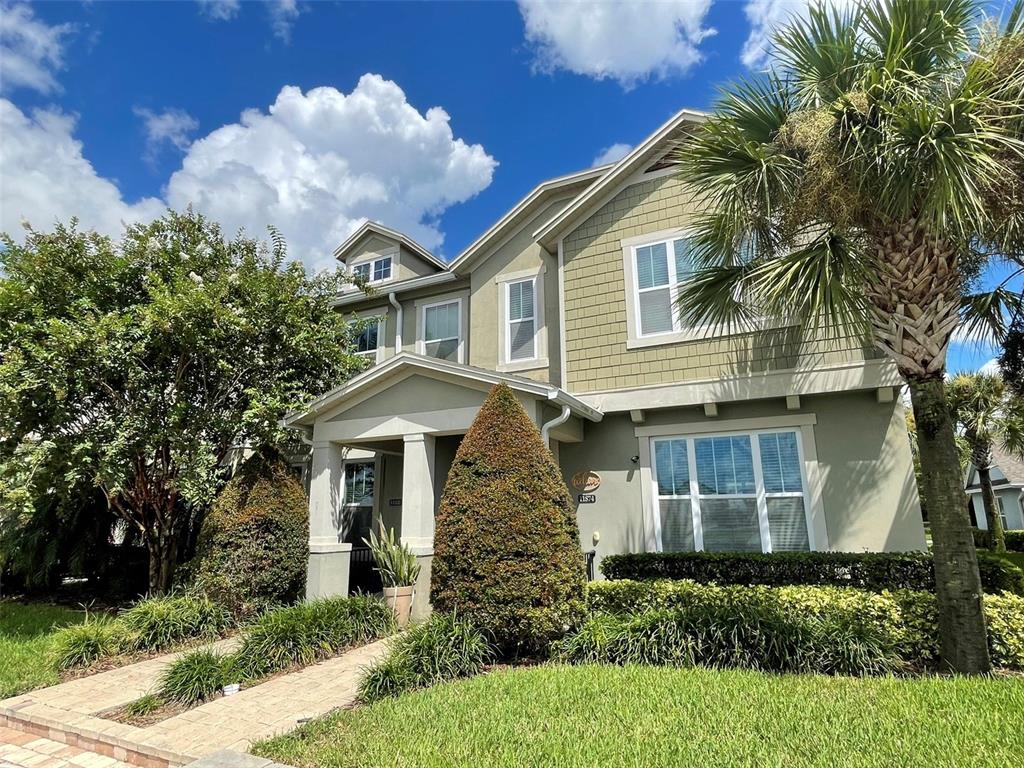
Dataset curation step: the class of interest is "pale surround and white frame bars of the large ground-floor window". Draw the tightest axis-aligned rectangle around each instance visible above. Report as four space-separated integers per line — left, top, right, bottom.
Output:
635 417 828 553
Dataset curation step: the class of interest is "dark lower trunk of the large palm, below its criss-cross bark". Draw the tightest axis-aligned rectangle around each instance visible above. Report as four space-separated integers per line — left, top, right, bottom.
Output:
907 372 991 674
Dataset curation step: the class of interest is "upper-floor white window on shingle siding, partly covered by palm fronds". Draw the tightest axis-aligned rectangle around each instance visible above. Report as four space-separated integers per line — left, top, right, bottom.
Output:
633 238 694 336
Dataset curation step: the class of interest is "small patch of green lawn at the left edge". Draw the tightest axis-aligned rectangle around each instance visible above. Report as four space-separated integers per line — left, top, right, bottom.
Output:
0 601 85 698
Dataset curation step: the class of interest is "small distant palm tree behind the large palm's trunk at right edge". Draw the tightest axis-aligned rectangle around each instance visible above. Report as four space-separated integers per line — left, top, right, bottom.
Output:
946 373 1024 552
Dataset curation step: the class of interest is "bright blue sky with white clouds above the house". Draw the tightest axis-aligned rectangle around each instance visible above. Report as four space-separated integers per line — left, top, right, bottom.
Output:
0 0 1015 369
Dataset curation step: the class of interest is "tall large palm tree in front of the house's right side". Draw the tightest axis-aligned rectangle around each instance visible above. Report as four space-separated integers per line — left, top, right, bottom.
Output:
676 0 1024 673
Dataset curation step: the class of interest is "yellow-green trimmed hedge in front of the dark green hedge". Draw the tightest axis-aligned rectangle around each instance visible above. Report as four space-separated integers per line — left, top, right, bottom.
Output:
587 580 1024 670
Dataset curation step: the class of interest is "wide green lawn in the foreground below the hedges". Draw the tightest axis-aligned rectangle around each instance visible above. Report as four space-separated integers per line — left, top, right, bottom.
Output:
253 667 1024 768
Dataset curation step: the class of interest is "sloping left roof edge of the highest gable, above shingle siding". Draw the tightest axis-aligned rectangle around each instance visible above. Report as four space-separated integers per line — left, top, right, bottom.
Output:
534 110 707 249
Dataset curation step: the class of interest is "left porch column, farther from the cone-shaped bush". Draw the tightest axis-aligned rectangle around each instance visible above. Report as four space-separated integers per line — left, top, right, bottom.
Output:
306 442 352 599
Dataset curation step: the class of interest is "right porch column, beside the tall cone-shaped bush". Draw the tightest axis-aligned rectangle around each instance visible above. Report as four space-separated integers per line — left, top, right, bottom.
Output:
401 433 434 618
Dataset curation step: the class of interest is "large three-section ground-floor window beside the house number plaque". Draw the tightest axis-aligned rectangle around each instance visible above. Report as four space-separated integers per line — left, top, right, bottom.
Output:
650 429 812 552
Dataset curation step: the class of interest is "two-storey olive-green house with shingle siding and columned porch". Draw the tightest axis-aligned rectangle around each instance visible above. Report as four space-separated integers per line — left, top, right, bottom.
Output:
285 111 925 614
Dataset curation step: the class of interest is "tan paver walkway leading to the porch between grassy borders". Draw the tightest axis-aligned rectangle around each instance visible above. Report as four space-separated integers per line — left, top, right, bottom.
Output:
0 640 387 768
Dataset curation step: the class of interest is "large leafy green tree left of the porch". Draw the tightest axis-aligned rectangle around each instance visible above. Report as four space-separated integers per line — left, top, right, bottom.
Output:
0 211 361 593
